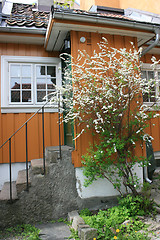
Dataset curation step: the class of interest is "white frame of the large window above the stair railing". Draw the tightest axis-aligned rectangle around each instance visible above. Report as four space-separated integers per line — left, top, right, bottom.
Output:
1 56 62 113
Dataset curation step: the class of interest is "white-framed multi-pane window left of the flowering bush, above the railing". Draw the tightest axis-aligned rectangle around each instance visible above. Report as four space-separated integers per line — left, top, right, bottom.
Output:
1 56 61 112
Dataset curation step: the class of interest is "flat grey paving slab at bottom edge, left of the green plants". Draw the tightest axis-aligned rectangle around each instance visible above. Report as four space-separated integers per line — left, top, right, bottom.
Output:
36 222 71 240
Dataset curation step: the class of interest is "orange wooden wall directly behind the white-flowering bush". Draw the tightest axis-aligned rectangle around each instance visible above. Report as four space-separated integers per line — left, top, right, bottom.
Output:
71 31 145 167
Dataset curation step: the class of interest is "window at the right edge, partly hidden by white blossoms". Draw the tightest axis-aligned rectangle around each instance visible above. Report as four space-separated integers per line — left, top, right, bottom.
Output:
142 64 160 105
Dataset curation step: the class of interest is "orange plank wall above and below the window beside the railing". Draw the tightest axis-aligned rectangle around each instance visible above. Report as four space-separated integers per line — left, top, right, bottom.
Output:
0 43 63 163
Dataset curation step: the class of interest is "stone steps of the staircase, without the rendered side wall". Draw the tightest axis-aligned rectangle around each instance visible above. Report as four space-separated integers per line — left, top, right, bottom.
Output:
0 146 71 201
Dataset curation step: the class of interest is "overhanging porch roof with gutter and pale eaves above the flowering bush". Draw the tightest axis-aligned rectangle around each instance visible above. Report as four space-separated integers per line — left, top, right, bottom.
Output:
45 7 160 51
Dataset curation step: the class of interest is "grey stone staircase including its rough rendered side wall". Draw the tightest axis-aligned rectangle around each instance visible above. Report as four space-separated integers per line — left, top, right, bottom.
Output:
0 146 80 229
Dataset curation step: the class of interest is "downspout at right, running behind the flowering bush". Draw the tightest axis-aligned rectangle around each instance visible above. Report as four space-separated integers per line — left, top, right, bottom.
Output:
141 28 160 184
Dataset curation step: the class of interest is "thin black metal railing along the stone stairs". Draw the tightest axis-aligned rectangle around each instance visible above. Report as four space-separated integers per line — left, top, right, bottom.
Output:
0 94 61 202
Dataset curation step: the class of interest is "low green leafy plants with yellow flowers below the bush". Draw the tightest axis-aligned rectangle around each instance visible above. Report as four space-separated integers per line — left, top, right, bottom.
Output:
81 195 150 240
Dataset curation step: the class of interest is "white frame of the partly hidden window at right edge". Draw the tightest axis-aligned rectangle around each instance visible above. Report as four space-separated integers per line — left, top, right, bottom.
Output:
141 63 160 107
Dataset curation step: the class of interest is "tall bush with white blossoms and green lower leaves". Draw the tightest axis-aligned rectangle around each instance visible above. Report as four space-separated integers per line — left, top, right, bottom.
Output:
52 39 158 195
